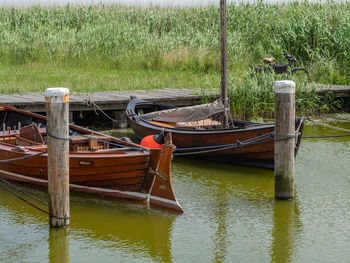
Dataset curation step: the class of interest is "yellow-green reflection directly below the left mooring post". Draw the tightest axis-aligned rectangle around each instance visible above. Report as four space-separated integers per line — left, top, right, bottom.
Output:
49 227 70 263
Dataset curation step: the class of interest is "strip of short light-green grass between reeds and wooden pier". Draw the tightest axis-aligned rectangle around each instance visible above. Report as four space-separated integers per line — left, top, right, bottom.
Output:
0 63 220 93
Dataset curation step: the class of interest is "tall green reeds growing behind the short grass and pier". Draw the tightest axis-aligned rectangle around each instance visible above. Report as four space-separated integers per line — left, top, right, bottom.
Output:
0 2 350 117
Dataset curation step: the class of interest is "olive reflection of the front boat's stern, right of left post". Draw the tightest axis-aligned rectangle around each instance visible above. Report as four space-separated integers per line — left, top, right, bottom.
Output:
71 198 177 262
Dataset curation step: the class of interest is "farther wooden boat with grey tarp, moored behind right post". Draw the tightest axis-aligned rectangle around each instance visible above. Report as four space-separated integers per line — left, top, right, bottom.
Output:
126 98 304 168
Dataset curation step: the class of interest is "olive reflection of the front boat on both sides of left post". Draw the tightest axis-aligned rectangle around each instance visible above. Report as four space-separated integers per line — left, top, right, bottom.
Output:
0 184 178 262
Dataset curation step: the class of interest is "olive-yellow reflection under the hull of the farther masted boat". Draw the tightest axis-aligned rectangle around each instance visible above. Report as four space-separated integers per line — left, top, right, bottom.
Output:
173 157 274 201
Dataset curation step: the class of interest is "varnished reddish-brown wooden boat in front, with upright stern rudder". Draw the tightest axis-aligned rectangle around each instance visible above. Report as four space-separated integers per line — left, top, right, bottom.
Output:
0 104 183 212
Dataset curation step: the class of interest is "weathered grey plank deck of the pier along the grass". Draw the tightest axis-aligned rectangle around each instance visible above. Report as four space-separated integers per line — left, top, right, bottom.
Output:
0 85 350 112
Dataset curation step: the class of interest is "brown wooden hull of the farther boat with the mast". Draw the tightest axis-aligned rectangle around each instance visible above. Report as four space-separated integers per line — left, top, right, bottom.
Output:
127 99 303 168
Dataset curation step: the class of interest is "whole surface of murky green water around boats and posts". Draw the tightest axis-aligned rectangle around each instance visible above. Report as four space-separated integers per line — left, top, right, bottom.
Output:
0 122 350 263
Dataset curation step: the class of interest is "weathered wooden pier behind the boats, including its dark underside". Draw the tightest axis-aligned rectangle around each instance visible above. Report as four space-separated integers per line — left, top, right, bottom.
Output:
0 85 350 127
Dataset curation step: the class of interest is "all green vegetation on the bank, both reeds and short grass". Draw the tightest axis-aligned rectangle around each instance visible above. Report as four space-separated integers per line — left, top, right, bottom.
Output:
0 2 350 117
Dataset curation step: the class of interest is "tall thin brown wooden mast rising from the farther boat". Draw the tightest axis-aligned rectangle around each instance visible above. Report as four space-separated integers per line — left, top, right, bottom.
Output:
220 0 229 128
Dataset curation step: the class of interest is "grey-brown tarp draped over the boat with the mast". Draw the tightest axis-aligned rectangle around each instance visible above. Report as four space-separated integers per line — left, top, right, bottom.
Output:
142 99 225 122
